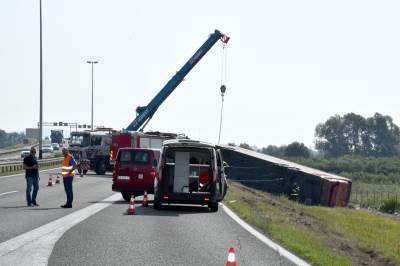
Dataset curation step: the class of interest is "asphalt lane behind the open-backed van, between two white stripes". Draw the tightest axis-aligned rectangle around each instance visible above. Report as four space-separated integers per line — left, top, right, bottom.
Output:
49 201 293 265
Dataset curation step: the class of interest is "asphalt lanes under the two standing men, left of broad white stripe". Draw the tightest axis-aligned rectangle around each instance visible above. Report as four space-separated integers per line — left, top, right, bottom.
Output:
0 170 113 243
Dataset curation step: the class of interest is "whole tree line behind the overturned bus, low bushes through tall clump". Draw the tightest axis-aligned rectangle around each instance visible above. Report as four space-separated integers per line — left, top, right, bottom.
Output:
233 113 400 158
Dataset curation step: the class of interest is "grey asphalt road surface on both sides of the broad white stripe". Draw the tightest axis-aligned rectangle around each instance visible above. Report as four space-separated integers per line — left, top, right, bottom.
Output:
0 170 300 265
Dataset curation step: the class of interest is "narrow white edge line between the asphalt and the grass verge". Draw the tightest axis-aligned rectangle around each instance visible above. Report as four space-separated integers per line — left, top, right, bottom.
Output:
221 203 310 266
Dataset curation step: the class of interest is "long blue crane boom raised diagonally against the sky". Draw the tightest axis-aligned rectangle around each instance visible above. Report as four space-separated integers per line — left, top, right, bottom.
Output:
126 30 229 131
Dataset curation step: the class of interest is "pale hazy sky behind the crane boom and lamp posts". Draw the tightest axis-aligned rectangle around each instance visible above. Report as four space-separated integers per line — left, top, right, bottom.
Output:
0 0 400 147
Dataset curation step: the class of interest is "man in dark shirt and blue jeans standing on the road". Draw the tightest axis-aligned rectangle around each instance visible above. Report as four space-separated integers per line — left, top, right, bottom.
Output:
24 147 39 207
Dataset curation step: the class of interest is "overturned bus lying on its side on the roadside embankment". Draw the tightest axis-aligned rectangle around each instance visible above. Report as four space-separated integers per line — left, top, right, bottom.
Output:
221 146 352 207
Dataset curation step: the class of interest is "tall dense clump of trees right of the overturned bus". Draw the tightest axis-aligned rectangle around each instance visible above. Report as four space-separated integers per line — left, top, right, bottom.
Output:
315 113 400 157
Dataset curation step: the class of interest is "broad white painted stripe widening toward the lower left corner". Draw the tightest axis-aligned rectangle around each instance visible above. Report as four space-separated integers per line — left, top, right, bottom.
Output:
0 193 122 266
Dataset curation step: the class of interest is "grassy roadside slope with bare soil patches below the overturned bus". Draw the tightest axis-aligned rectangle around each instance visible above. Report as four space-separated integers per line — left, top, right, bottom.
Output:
224 182 400 265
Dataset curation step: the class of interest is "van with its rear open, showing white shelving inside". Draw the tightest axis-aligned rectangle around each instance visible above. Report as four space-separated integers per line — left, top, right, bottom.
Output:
154 139 227 212
